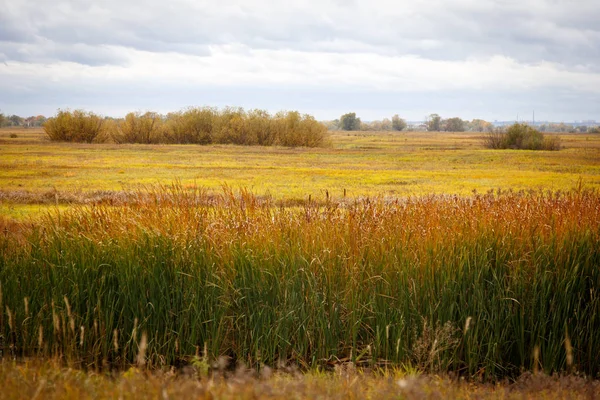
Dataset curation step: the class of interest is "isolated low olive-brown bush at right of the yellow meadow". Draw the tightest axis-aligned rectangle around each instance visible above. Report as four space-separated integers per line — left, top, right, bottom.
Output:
484 123 560 150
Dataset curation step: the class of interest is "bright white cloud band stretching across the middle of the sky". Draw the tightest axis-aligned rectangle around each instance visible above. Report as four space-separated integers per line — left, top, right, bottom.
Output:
0 45 600 93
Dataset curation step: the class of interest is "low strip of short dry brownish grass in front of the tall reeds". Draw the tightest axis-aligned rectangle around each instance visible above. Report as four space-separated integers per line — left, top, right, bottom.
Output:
0 361 600 399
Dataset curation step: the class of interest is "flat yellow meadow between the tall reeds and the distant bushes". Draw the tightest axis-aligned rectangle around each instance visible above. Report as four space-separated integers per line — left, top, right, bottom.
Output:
0 129 600 215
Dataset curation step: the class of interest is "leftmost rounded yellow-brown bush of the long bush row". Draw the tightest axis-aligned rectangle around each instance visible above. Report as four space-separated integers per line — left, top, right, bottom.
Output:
44 110 105 143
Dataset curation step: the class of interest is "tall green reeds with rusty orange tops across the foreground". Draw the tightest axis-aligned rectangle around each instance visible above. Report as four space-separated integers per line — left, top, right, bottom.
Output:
0 185 600 378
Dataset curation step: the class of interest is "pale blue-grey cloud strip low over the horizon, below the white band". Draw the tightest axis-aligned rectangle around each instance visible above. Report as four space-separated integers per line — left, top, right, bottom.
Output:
0 75 600 121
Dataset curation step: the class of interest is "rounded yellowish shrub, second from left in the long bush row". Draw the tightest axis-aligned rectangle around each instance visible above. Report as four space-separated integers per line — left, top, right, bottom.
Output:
112 112 166 144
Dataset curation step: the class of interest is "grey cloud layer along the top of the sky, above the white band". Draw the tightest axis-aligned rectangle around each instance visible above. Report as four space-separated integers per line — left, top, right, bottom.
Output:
0 0 600 66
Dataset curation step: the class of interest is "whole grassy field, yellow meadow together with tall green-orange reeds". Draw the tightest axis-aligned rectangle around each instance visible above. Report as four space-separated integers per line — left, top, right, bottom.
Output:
0 130 600 398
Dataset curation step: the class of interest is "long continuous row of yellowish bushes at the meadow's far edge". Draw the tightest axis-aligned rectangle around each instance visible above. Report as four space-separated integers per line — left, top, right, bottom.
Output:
43 107 327 147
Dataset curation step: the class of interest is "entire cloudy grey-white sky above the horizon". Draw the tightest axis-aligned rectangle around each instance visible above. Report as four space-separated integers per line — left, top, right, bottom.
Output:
0 0 600 122
